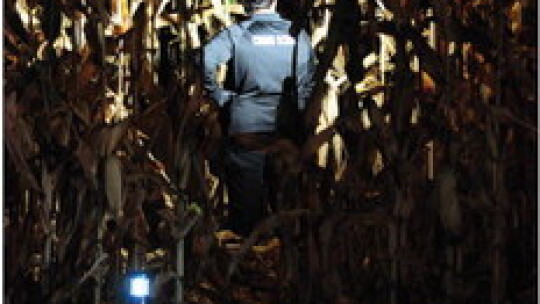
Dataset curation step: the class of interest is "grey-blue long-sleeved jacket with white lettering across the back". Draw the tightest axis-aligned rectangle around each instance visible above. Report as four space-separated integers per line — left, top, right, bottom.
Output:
204 14 314 134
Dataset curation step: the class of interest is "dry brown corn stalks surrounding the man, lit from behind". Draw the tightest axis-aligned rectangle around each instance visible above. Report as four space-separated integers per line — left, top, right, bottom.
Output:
3 0 538 304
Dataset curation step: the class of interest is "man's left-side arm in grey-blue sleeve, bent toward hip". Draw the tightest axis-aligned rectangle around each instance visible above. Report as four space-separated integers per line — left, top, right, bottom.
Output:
202 29 234 107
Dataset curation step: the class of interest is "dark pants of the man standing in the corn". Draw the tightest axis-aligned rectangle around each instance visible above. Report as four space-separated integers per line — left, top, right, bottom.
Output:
224 144 266 236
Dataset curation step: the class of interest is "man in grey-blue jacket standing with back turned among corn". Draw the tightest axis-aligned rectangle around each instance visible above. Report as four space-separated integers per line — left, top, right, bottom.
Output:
203 0 315 236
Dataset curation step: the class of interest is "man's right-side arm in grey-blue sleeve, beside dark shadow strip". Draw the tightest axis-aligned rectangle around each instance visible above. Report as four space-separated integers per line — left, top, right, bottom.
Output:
297 31 315 110
